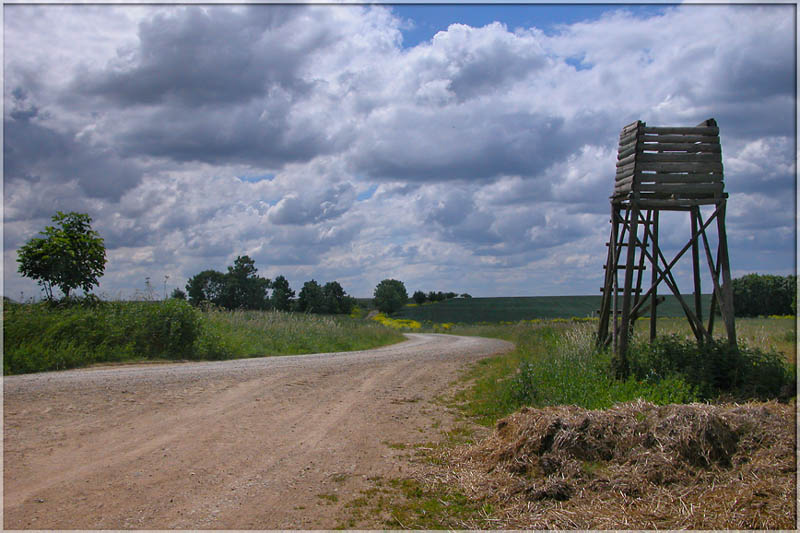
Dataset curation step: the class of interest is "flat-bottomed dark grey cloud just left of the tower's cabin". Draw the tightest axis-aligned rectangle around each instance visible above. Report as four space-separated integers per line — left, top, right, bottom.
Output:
354 109 574 182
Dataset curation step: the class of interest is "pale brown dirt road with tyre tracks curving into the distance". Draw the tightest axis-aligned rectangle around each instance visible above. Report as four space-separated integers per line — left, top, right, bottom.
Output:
3 334 511 529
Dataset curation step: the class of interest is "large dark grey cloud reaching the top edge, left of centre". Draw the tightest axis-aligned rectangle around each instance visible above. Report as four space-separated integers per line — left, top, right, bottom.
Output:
74 6 318 107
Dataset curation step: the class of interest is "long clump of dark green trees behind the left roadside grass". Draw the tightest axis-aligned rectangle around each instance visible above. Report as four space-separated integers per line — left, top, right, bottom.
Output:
183 255 355 315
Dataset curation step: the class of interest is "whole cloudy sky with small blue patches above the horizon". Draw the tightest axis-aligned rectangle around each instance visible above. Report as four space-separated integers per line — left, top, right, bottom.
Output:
3 5 796 298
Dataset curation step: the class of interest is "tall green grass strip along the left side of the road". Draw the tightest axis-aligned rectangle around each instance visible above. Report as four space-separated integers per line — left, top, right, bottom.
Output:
3 300 404 375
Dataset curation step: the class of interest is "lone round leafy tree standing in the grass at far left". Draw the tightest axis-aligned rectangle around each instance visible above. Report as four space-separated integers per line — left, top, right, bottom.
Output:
17 211 106 300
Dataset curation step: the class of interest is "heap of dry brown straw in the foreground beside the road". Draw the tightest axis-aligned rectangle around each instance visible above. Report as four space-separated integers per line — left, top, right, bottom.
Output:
428 401 797 529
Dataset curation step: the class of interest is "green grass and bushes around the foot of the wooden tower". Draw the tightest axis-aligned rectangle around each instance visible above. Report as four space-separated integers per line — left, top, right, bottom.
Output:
450 318 796 426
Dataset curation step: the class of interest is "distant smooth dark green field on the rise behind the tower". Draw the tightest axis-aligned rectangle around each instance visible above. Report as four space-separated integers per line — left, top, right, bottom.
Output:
393 295 711 324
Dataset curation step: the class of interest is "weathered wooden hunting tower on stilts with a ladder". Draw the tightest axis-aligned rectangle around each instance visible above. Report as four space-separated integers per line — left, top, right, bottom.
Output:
598 119 736 376
